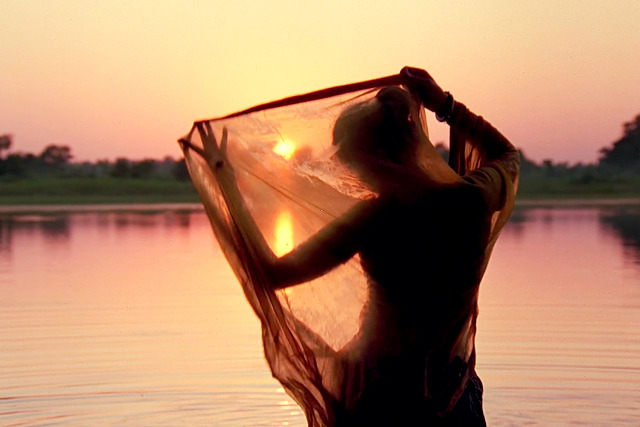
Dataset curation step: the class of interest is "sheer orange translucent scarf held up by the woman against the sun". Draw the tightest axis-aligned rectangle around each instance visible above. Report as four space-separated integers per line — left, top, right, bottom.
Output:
180 76 515 425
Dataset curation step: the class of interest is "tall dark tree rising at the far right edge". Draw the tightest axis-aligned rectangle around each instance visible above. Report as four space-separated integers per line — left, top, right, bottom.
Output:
599 114 640 173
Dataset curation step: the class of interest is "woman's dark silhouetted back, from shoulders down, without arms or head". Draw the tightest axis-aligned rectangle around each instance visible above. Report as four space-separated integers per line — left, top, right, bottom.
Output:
330 183 490 425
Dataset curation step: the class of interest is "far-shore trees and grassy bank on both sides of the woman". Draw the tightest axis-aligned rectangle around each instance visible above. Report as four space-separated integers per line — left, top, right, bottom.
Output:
0 114 640 204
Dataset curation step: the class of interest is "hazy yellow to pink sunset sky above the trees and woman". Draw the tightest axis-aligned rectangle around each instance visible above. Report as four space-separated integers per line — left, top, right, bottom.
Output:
0 0 640 162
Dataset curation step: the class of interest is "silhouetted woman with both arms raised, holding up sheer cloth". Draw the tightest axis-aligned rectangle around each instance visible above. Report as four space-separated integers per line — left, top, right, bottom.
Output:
197 68 519 425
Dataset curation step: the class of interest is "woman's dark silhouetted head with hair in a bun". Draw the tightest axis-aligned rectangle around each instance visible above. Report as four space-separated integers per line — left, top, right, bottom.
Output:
333 86 418 165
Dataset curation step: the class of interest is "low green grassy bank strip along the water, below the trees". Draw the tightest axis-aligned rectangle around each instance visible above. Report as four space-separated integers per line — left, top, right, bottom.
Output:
0 176 640 214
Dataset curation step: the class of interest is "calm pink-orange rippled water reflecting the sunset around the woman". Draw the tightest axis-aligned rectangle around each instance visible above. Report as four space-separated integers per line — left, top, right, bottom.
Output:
0 207 640 425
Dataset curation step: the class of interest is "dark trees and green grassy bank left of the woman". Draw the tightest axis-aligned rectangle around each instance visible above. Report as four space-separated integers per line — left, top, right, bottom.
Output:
0 141 198 204
